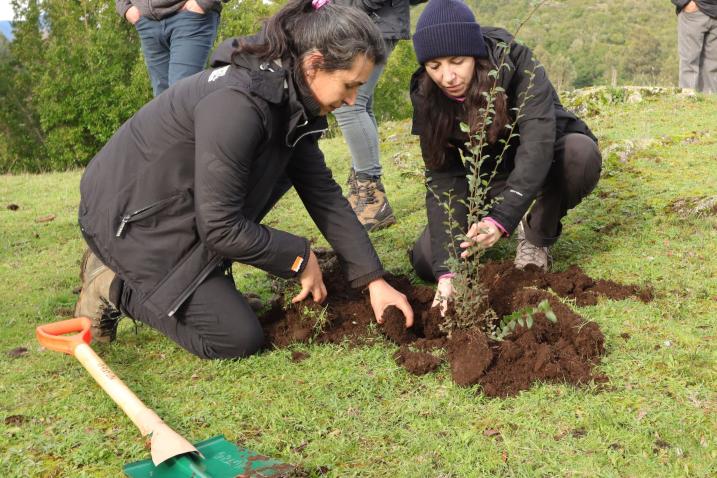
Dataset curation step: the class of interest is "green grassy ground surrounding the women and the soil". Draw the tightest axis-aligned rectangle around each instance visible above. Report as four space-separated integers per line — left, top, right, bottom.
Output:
0 88 717 477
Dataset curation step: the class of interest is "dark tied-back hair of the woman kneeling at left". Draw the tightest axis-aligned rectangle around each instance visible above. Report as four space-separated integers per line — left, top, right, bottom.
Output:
238 0 386 72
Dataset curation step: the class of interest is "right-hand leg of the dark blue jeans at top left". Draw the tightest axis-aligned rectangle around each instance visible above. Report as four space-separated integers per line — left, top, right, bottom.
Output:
167 10 219 86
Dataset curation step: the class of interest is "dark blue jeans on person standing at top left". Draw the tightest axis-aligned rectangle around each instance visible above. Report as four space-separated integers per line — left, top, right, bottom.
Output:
134 10 219 96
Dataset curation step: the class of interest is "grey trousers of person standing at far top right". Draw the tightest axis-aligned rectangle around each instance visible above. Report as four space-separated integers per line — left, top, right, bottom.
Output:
677 10 710 91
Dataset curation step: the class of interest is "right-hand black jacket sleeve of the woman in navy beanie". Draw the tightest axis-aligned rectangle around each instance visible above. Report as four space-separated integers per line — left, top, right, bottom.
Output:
488 44 556 233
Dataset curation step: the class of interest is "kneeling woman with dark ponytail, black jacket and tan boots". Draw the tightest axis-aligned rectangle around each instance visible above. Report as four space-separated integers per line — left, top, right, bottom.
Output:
75 0 413 358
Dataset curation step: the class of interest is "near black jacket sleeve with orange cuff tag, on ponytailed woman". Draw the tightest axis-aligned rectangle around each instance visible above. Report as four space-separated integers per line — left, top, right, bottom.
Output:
194 89 309 278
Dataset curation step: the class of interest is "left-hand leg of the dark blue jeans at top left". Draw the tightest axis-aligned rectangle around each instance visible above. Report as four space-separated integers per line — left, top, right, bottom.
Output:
134 17 169 96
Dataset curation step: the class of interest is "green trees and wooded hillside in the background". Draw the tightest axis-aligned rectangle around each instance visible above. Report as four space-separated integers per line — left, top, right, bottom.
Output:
0 0 678 173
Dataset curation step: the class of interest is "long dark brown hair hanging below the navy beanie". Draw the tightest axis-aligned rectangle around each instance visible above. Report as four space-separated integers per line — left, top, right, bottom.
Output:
419 58 510 169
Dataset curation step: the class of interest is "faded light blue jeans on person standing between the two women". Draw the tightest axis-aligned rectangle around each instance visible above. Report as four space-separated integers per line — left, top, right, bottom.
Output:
334 40 397 177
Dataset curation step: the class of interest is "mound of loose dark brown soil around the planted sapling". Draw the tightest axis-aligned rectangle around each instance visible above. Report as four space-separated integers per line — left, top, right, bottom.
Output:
260 253 652 397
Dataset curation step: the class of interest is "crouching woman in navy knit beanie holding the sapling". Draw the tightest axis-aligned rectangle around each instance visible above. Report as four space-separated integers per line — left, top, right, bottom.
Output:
411 0 602 310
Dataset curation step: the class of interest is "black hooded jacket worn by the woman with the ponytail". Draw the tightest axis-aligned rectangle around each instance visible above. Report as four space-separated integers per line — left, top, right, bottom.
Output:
79 38 383 322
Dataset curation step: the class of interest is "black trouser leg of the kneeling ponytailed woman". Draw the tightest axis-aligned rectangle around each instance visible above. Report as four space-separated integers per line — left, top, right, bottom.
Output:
121 269 264 359
